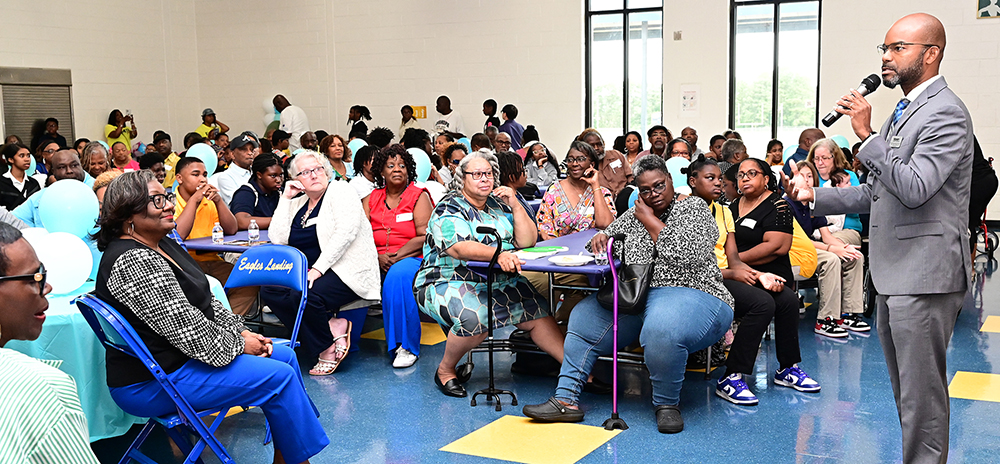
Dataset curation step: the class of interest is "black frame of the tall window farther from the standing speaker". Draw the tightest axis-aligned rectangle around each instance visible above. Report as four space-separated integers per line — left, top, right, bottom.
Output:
583 0 666 134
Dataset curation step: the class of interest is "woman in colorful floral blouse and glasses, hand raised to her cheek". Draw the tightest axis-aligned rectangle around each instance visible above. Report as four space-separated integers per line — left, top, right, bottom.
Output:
525 141 616 322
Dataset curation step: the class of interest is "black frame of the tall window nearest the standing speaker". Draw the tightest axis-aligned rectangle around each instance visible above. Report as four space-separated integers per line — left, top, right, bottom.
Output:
728 0 823 139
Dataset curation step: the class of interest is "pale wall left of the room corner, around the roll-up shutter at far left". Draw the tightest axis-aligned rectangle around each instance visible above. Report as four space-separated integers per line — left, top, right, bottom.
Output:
0 0 201 146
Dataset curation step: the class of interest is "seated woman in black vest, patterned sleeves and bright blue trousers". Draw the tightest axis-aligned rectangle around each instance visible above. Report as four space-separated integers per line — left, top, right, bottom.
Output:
94 171 330 462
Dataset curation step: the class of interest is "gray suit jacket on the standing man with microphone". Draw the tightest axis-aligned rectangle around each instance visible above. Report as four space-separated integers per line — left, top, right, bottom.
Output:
813 77 973 295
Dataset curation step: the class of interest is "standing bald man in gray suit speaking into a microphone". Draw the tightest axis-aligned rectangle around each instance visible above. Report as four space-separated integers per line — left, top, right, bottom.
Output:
792 14 973 464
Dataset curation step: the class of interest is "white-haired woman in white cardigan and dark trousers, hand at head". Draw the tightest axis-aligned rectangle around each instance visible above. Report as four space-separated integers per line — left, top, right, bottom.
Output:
260 150 381 376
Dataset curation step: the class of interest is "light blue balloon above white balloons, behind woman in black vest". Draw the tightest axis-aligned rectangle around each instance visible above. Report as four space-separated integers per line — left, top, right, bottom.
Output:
38 179 99 237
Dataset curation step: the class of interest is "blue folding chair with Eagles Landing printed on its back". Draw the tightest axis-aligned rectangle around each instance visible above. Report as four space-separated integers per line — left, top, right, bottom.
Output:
225 244 309 348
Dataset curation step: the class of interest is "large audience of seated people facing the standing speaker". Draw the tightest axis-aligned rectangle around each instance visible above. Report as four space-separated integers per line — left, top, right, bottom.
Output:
0 98 916 456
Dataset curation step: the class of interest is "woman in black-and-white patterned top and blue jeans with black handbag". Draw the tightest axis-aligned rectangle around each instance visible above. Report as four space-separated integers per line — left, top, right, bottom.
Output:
524 156 733 433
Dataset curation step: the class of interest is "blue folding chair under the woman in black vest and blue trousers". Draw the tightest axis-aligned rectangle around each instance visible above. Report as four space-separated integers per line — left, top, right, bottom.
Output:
74 294 235 464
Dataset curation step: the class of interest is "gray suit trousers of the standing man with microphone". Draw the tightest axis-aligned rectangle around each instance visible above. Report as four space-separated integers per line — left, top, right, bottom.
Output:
876 292 966 464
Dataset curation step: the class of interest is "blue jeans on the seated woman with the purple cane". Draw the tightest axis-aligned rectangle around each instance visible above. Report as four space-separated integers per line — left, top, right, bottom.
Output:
555 287 733 406
